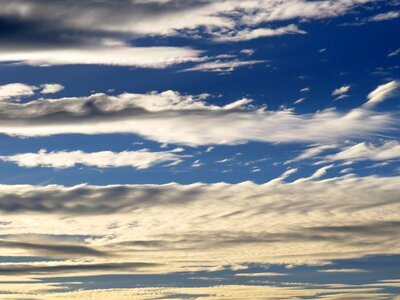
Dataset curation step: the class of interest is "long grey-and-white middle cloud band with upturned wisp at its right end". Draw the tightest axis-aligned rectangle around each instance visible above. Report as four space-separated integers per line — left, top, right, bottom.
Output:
0 82 397 146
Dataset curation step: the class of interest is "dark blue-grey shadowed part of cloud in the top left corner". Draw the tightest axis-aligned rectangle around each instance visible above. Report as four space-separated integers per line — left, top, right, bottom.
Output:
0 0 205 49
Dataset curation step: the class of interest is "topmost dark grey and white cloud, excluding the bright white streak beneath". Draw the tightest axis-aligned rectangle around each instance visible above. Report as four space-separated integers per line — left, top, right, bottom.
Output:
0 0 382 60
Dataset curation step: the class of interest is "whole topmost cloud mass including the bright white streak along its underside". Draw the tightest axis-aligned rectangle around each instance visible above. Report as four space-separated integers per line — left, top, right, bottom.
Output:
0 0 373 68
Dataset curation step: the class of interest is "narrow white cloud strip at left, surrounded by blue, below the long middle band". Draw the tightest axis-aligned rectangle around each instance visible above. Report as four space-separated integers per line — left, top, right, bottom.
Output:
0 149 187 170
